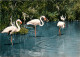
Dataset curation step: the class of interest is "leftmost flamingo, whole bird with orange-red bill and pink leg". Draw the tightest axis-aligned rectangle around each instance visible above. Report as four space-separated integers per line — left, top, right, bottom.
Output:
1 19 22 45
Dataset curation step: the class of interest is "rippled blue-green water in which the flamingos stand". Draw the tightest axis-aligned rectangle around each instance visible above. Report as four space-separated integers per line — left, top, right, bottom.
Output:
0 21 80 57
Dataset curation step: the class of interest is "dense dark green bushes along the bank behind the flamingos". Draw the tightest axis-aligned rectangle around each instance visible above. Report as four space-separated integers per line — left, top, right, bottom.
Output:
0 0 80 30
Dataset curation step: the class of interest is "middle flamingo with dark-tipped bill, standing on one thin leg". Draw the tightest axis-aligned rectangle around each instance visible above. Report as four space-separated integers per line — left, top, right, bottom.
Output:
27 16 48 37
